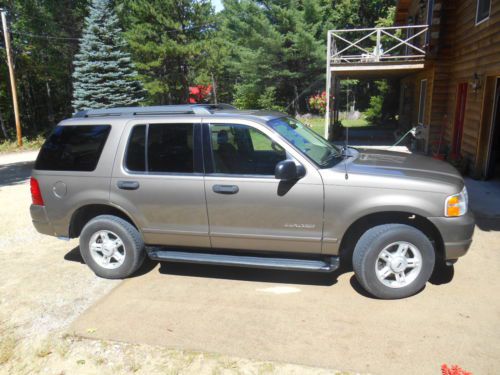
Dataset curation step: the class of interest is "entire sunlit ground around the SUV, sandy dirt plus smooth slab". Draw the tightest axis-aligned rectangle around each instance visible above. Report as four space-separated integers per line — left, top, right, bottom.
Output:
0 154 500 375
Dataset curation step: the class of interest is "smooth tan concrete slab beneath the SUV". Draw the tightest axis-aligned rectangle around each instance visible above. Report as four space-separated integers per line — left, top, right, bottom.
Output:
70 225 500 375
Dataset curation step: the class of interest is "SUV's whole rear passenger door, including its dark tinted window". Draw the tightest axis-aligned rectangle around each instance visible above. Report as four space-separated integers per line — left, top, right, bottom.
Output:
111 118 210 247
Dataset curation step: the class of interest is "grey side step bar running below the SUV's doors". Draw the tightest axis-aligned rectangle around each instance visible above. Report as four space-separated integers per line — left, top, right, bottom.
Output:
148 248 339 272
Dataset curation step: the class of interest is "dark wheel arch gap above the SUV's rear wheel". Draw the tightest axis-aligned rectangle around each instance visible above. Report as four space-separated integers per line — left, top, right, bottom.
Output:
68 203 141 238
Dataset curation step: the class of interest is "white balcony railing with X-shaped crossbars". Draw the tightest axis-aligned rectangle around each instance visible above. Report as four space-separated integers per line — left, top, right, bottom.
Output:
328 25 429 64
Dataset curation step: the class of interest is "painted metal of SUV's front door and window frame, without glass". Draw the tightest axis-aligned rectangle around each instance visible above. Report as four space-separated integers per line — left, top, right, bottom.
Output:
204 117 323 254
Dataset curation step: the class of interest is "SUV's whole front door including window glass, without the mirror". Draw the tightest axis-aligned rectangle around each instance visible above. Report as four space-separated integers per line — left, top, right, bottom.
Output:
203 120 323 253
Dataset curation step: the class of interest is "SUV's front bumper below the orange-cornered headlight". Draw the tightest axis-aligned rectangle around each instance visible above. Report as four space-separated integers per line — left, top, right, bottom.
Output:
429 211 476 260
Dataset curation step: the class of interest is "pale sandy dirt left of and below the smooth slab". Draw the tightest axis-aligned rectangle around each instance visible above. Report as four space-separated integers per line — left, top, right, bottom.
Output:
0 152 348 375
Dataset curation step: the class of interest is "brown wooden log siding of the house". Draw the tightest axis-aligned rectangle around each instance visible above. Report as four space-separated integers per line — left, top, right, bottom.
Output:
396 0 500 177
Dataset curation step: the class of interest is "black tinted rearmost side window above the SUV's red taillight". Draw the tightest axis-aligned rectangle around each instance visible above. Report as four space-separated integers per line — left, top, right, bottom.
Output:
35 125 111 172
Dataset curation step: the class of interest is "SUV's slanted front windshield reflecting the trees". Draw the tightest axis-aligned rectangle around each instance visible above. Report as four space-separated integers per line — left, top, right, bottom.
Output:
267 117 341 168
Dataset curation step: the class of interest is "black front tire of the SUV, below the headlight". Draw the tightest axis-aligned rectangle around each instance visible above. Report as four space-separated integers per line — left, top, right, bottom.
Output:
352 224 436 299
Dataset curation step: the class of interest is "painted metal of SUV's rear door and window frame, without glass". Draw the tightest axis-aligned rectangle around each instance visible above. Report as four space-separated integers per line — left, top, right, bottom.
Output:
110 117 210 247
